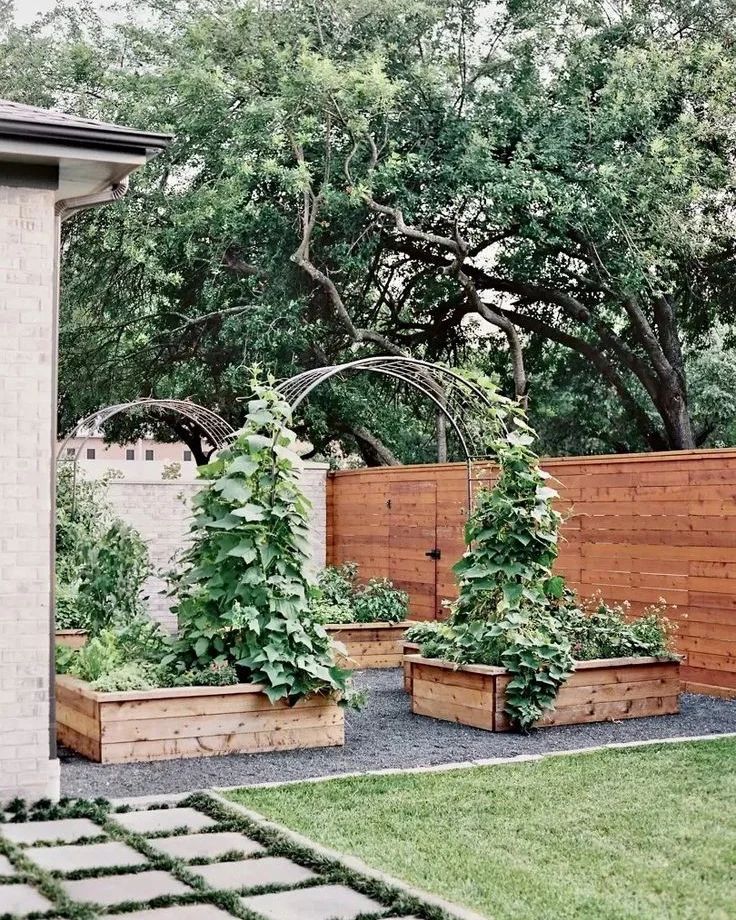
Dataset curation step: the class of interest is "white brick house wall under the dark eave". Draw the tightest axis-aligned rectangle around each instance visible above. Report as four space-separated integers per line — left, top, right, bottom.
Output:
0 185 59 802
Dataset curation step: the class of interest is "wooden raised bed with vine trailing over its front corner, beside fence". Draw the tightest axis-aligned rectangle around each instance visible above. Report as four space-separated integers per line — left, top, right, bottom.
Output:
405 655 680 732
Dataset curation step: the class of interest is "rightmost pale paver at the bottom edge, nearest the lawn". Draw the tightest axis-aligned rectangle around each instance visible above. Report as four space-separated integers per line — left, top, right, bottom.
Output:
240 885 386 920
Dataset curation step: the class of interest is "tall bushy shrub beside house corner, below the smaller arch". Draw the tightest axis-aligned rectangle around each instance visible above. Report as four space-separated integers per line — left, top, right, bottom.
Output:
55 465 150 635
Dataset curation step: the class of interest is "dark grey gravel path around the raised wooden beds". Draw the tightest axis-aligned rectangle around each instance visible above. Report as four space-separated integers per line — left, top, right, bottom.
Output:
60 669 736 797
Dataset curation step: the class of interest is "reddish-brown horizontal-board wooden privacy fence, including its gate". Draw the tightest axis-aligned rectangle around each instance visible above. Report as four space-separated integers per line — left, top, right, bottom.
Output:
327 449 736 697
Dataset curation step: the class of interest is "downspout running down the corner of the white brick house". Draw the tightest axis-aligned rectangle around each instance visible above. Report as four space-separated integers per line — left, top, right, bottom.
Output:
49 176 129 760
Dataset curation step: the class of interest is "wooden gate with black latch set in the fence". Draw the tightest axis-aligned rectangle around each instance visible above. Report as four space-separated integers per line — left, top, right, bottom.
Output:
386 479 438 620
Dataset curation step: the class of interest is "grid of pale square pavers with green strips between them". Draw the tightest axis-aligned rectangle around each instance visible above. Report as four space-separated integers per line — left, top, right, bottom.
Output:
0 796 452 920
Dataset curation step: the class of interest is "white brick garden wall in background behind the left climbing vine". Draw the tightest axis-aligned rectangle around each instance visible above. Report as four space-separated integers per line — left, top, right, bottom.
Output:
108 464 327 630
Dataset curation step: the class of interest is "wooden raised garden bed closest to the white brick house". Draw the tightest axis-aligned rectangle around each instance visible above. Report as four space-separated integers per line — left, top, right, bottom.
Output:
56 675 345 763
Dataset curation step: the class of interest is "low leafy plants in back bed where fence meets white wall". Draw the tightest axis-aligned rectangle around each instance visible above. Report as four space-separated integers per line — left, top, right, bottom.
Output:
312 562 409 623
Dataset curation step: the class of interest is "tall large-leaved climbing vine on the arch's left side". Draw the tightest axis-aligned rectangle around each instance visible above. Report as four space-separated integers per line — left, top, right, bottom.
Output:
168 378 349 702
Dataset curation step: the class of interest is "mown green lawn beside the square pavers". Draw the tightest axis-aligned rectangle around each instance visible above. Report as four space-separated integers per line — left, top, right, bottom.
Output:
229 739 736 920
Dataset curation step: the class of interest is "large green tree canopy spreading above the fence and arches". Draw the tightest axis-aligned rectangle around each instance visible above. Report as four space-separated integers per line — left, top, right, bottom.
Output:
0 0 736 462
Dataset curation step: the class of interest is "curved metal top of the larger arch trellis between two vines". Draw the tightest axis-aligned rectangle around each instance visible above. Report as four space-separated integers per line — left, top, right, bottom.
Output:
277 355 508 509
